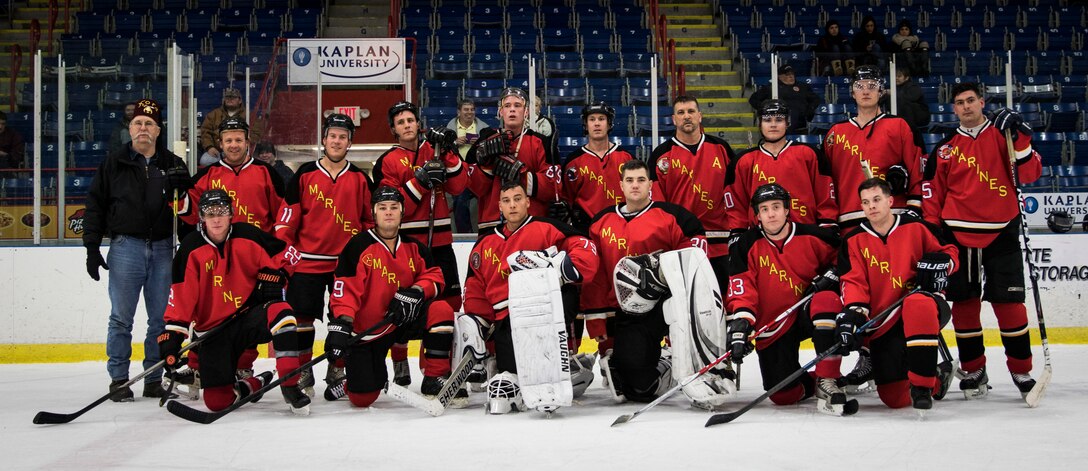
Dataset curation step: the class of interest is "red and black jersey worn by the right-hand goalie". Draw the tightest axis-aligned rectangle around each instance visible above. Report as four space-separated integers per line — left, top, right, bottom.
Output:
581 201 707 337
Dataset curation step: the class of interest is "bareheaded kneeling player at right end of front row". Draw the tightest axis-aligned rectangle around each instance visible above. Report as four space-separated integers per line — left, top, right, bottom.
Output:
826 178 957 410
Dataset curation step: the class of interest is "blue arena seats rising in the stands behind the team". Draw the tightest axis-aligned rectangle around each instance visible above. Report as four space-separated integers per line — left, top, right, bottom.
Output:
6 0 1088 205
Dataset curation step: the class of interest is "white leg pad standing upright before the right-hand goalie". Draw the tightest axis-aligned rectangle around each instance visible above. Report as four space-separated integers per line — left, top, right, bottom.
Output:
659 248 737 407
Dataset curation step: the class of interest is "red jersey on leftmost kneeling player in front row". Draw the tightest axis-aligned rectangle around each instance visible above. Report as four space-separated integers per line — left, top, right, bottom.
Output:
163 223 299 335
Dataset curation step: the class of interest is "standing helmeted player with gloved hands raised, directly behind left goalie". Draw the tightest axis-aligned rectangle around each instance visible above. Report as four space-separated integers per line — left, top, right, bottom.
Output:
467 87 560 233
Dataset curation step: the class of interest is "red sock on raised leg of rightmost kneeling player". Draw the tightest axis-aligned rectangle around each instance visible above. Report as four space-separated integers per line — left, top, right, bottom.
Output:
901 294 940 388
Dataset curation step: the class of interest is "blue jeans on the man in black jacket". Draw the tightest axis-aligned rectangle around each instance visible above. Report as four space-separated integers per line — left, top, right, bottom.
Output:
106 236 173 383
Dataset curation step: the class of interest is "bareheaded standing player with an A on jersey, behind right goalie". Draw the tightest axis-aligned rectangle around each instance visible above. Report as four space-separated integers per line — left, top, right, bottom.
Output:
650 95 735 292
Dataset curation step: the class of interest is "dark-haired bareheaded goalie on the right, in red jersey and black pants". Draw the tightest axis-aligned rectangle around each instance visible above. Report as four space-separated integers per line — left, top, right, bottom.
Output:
582 159 731 407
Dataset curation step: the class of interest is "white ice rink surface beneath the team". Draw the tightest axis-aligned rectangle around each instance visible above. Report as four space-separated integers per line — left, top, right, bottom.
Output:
0 345 1088 471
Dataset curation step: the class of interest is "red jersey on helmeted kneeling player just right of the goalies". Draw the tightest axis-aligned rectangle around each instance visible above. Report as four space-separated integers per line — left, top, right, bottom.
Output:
726 223 839 349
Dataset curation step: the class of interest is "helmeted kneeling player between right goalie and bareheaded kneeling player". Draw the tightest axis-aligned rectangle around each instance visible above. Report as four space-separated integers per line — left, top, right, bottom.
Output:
726 183 841 409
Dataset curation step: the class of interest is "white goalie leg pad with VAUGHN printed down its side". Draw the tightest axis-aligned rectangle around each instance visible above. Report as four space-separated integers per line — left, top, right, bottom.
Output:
509 268 573 411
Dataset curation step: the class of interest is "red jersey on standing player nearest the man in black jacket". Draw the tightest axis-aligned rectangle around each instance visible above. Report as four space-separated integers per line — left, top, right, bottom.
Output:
177 158 284 233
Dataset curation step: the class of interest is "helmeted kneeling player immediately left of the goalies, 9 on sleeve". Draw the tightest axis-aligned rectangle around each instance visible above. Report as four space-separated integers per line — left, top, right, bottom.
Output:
325 186 454 407
